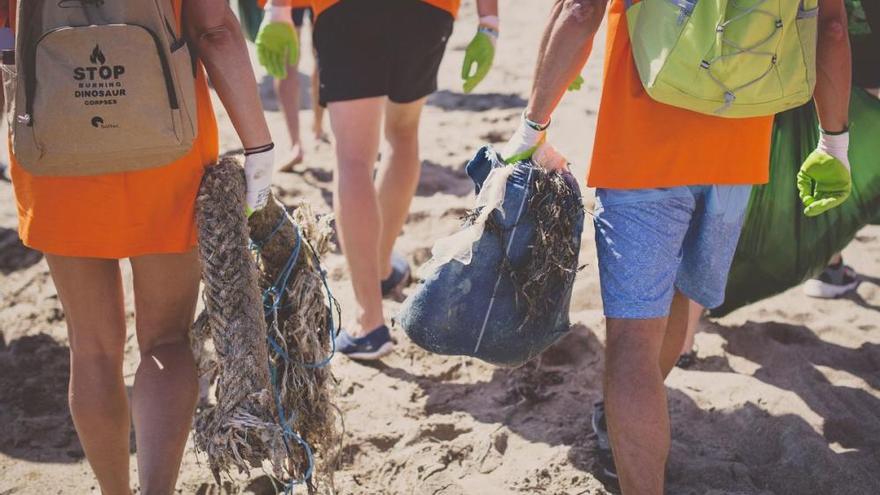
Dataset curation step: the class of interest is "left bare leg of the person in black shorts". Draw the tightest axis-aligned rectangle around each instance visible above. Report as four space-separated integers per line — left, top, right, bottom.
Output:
328 97 385 337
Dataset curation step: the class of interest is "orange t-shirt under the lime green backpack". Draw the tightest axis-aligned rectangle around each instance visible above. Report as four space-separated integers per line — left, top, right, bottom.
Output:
587 0 773 189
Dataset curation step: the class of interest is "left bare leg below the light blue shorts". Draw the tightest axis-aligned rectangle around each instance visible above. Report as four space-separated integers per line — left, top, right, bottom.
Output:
605 318 668 495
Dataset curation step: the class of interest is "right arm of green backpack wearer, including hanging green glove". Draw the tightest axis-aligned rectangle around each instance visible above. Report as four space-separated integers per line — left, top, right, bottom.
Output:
797 0 852 216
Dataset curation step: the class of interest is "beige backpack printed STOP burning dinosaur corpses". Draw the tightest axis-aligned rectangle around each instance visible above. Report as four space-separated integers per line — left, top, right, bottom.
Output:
4 0 198 176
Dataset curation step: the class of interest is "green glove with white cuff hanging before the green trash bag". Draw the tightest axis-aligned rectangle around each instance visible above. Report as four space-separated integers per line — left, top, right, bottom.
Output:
797 133 852 217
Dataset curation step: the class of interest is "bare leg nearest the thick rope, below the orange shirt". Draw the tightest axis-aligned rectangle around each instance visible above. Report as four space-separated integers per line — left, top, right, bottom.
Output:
131 250 199 495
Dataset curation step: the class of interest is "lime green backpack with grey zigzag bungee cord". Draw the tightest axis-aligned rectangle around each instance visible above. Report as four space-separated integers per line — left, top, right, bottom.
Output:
624 0 819 118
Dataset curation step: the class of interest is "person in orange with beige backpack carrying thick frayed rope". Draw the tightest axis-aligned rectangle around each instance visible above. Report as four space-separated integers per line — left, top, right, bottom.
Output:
3 0 274 495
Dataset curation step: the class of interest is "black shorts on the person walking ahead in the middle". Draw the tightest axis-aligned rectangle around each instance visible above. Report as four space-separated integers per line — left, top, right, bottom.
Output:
313 0 453 105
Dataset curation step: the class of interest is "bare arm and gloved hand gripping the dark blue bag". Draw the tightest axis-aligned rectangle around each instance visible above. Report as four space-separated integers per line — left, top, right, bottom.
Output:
502 0 607 167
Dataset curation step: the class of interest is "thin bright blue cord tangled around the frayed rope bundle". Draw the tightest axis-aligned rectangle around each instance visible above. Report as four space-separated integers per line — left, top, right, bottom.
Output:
250 214 336 494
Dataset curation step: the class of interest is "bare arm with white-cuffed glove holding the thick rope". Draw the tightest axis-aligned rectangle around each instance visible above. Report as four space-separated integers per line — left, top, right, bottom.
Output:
183 0 274 211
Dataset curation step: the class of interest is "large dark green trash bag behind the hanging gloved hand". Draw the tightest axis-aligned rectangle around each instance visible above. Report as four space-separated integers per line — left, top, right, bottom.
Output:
712 88 880 316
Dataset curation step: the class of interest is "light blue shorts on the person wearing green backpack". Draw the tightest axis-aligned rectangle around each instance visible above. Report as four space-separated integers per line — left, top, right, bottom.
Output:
595 186 751 319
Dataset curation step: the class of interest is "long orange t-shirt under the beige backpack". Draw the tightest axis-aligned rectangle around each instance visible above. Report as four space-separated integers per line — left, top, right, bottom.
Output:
10 0 219 258
